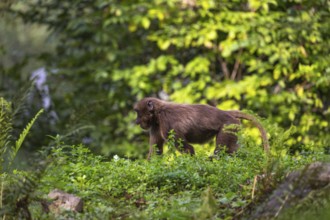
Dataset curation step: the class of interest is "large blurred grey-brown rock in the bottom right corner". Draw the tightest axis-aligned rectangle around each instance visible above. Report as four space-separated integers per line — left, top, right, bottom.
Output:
250 162 330 219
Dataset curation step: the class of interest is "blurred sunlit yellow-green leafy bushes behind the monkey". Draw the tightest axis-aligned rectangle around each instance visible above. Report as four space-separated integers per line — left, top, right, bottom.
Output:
0 0 330 158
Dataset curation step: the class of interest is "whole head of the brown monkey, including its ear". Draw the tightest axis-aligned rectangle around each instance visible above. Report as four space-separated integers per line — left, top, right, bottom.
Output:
134 98 162 129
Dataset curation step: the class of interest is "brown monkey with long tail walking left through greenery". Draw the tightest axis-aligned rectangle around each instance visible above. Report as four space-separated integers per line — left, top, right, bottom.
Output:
134 98 269 160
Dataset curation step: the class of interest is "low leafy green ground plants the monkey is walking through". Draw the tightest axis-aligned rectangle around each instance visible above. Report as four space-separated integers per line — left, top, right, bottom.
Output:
39 128 326 219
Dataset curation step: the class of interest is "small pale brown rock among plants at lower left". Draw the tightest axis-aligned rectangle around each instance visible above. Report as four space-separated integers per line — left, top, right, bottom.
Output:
48 189 83 213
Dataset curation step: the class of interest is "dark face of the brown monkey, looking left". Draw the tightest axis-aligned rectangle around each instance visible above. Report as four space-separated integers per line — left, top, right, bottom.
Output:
134 100 154 130
